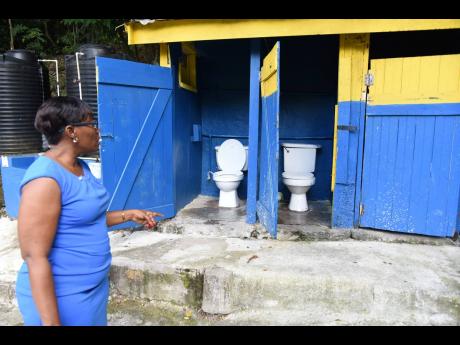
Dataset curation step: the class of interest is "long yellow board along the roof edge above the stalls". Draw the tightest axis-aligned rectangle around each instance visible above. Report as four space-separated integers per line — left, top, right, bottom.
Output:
125 19 460 44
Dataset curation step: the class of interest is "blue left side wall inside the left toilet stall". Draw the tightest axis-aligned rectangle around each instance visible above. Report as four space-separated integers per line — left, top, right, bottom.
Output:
171 44 202 210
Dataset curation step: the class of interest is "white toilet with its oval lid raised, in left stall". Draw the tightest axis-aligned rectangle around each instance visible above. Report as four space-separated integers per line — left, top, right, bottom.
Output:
212 139 248 207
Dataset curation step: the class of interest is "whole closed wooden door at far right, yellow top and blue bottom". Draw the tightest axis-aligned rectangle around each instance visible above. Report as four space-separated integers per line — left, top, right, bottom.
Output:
360 55 460 237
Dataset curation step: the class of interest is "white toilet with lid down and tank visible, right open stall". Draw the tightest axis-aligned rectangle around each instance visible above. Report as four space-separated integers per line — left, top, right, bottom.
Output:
281 143 321 212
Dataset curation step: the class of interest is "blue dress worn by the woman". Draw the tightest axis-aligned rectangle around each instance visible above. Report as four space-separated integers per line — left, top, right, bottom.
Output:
16 156 112 326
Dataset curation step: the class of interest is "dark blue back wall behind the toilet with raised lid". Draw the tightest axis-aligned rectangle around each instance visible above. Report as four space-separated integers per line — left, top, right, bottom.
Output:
196 40 250 199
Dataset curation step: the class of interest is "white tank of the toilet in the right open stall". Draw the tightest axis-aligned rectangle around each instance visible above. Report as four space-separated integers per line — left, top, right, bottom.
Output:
281 143 321 174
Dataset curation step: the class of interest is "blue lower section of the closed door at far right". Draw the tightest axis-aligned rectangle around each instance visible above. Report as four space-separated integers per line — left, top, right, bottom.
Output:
360 104 460 237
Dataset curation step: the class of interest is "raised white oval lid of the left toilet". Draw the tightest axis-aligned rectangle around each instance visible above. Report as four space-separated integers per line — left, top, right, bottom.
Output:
216 139 246 173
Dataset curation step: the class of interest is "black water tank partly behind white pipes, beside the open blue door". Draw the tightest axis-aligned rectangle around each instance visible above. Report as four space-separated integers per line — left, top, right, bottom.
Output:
65 44 117 117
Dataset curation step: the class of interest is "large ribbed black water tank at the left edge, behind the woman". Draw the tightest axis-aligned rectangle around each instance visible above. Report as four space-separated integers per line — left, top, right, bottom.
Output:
0 49 49 154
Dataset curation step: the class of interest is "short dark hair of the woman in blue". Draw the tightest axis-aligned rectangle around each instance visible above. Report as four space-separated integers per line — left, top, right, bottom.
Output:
34 96 93 145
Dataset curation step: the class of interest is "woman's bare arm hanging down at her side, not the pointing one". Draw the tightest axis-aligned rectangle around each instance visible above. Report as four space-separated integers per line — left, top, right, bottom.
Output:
18 177 61 326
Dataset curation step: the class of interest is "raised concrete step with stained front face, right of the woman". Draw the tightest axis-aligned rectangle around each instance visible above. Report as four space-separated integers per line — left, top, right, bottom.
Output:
107 233 460 325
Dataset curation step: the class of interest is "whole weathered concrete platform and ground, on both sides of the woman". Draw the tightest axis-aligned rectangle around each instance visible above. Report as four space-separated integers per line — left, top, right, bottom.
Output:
0 199 460 325
